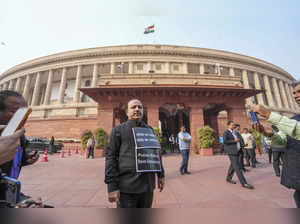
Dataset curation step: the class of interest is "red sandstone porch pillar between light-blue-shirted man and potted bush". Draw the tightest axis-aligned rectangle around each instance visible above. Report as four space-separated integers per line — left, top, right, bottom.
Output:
190 106 204 151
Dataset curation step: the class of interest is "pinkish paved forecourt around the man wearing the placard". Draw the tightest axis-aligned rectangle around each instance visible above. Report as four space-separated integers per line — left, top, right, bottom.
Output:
20 154 295 208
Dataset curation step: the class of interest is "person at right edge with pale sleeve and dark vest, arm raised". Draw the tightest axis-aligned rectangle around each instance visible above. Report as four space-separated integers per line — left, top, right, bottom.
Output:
251 82 300 208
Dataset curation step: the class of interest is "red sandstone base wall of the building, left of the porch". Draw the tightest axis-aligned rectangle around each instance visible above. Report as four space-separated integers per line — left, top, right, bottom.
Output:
25 118 99 139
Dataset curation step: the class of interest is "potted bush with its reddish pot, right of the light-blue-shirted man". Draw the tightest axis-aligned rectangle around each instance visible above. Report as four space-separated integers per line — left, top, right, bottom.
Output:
197 126 215 156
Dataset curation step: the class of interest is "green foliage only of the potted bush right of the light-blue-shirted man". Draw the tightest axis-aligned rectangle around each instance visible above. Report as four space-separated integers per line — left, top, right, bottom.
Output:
197 126 215 149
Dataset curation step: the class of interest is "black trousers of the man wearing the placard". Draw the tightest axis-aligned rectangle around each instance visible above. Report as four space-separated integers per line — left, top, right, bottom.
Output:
117 191 153 208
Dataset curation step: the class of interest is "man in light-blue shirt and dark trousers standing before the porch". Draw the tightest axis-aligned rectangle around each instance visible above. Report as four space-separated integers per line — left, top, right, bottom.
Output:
178 126 192 175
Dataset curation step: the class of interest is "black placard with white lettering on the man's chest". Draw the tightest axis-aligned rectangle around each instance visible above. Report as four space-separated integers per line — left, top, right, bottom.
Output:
132 128 161 172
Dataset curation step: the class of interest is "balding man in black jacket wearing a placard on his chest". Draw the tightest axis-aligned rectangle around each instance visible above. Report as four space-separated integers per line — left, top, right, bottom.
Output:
105 99 165 208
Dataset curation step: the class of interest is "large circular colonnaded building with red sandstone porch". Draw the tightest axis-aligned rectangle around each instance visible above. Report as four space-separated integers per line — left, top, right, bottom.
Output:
0 45 299 154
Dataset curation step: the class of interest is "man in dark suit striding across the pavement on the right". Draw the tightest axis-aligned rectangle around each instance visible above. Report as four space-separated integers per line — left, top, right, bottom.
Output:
223 121 254 189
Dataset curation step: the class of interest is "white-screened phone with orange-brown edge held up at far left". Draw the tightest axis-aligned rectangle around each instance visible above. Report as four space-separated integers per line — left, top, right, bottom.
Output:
1 107 32 136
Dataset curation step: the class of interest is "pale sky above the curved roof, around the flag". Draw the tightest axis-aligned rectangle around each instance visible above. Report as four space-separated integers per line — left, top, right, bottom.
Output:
0 0 300 78
